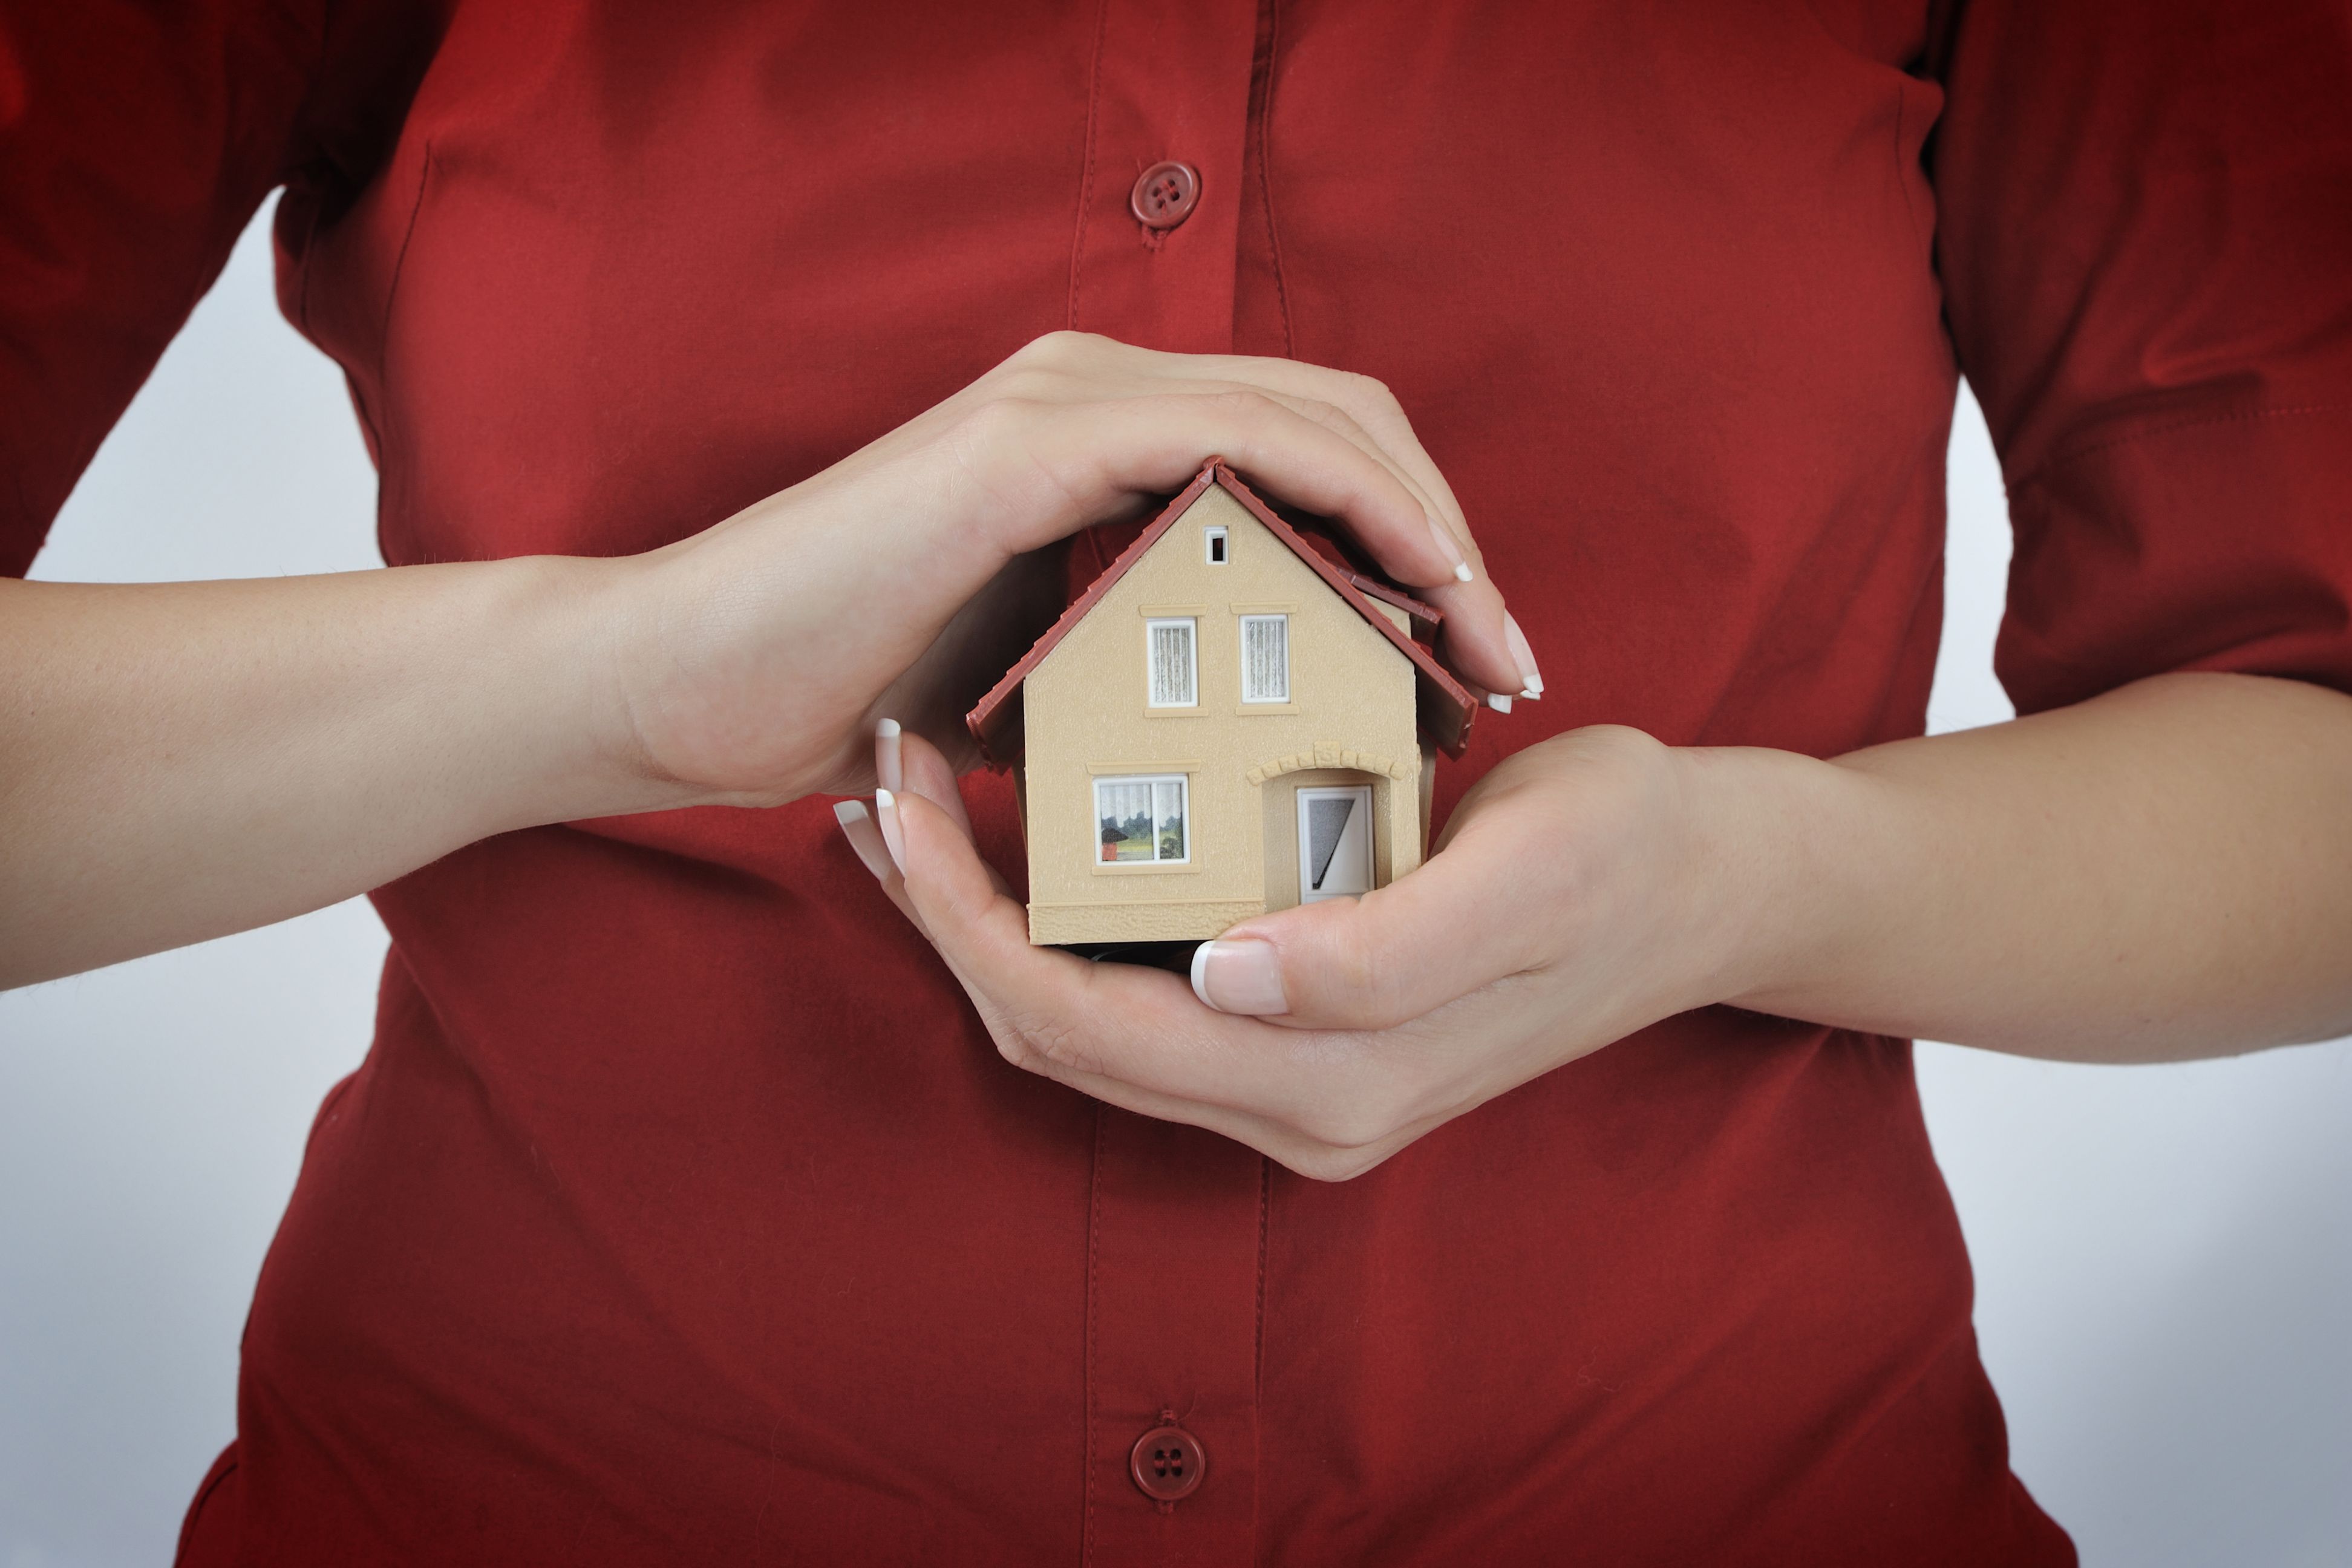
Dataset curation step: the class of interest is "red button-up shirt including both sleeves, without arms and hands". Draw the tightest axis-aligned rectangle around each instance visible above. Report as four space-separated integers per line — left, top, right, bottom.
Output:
0 0 2352 1566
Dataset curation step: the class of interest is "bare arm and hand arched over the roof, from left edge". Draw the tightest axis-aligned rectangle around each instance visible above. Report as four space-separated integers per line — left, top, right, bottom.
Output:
0 334 1524 985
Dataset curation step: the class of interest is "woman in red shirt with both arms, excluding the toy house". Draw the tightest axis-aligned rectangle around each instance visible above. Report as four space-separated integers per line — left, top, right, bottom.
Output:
0 0 2352 1563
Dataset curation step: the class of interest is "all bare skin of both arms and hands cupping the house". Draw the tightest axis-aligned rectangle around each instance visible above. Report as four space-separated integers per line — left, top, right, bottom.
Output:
0 334 2352 1180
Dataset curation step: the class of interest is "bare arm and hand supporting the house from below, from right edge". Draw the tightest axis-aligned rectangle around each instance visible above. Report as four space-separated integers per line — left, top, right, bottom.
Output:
844 675 2352 1180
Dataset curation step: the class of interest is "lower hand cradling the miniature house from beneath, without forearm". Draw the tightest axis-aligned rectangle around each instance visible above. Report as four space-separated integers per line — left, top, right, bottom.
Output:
840 727 1768 1180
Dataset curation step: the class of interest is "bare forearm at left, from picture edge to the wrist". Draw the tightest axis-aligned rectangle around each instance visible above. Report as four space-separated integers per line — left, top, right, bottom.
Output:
0 560 675 985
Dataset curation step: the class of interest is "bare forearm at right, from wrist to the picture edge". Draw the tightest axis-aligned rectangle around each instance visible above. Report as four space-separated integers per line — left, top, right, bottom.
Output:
1687 675 2352 1060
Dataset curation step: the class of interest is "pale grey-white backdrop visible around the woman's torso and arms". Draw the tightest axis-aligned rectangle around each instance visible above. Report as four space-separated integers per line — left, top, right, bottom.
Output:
0 207 2352 1568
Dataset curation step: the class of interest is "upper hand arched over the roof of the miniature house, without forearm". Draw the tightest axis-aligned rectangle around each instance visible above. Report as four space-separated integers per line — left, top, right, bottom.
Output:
604 332 1541 804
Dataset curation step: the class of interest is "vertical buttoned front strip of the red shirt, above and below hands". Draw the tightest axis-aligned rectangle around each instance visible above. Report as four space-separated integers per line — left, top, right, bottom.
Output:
1070 0 1266 1542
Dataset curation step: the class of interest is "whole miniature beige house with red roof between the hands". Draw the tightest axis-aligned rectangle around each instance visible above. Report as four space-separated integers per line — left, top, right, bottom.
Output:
967 461 1477 942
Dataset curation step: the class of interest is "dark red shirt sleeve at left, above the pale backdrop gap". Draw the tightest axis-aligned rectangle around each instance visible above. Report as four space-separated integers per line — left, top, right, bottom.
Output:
0 0 322 576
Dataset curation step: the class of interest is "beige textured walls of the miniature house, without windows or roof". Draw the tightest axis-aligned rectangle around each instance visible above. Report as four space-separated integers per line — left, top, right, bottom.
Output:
1021 486 1423 942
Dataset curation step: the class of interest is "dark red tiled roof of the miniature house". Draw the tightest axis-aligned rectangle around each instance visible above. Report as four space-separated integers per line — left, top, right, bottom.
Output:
964 459 1477 766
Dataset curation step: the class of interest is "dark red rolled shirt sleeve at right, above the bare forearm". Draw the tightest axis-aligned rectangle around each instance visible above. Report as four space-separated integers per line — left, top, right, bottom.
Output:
1929 0 2352 712
